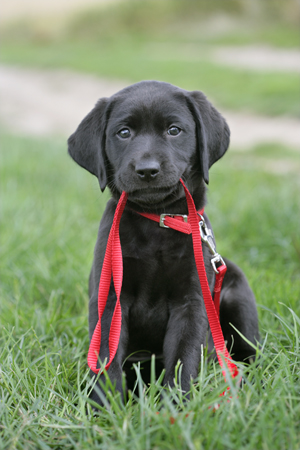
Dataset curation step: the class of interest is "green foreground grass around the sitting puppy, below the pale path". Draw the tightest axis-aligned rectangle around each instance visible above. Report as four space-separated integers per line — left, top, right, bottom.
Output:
0 136 300 450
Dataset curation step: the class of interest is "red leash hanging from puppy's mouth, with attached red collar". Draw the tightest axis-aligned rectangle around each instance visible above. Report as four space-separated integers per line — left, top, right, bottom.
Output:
87 180 238 390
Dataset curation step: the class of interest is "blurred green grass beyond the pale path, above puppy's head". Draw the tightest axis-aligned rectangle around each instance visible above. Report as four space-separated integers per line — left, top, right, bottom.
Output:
1 0 300 116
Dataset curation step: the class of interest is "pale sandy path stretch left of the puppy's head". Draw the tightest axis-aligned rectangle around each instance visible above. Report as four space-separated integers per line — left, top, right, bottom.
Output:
0 66 126 136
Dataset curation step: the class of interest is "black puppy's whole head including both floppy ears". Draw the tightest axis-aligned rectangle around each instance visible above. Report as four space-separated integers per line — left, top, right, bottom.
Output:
68 81 230 206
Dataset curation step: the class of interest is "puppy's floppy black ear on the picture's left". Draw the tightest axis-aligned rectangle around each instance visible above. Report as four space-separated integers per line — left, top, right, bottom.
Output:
68 98 108 192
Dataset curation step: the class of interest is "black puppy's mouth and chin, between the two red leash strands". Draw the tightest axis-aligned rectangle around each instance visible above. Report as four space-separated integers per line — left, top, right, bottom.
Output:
128 183 180 207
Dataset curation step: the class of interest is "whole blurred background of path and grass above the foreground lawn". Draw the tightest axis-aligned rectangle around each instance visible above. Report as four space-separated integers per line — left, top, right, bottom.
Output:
0 0 300 149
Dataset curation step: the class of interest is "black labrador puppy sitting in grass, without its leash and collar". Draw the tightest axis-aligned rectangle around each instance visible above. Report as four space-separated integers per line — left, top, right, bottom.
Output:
68 81 259 404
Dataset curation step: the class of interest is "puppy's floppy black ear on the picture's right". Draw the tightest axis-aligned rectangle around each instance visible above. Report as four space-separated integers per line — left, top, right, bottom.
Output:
187 91 230 184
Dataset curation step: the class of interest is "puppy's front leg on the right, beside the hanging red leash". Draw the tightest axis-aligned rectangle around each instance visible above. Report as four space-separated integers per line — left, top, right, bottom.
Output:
163 300 208 392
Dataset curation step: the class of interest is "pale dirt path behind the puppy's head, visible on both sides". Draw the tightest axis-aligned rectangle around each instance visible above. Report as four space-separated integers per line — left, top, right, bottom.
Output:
0 66 300 151
